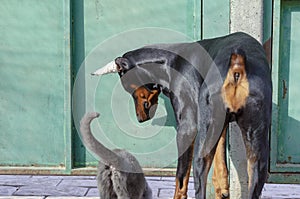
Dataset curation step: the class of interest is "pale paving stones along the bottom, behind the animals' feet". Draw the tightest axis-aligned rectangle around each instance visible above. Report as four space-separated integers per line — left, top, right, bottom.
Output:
0 175 300 199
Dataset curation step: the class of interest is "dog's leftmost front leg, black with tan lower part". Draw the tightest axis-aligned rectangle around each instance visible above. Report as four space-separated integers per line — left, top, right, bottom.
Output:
174 125 196 199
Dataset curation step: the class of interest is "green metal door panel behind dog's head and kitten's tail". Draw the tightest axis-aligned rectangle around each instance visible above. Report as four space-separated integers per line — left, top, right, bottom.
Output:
73 0 201 171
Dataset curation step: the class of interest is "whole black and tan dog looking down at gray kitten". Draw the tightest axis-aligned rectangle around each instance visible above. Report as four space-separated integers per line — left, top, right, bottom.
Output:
93 33 272 199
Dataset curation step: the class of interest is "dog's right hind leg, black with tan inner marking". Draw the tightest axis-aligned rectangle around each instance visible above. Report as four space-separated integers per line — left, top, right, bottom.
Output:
237 102 271 199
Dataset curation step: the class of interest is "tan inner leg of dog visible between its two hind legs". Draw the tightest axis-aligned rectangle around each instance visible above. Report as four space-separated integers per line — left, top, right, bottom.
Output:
212 128 229 199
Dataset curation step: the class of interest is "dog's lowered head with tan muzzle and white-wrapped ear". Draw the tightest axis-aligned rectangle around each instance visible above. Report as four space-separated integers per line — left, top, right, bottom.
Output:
92 53 160 122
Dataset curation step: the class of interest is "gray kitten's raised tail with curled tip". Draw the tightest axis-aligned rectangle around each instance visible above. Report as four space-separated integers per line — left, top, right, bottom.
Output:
80 112 120 167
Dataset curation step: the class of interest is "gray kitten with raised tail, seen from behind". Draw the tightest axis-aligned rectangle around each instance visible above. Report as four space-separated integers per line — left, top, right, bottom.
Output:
80 112 152 199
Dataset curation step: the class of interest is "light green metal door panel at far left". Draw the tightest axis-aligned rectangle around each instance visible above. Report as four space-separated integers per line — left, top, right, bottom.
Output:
0 0 71 173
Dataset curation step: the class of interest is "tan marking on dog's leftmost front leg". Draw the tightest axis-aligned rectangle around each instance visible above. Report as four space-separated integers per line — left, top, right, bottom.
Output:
174 143 194 199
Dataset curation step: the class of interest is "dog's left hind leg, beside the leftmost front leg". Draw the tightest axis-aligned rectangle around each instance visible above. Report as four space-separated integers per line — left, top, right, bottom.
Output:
193 90 226 199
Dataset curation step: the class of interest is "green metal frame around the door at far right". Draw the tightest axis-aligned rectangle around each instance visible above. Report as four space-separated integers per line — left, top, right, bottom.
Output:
268 0 300 183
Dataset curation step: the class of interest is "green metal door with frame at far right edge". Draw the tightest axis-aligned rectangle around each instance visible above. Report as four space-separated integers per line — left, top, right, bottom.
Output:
270 1 300 183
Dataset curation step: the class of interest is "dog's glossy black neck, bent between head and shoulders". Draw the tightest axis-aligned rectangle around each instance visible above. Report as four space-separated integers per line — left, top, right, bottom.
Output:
122 43 206 96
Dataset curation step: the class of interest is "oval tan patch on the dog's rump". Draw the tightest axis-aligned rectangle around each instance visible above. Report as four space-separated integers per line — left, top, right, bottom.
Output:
221 54 249 113
